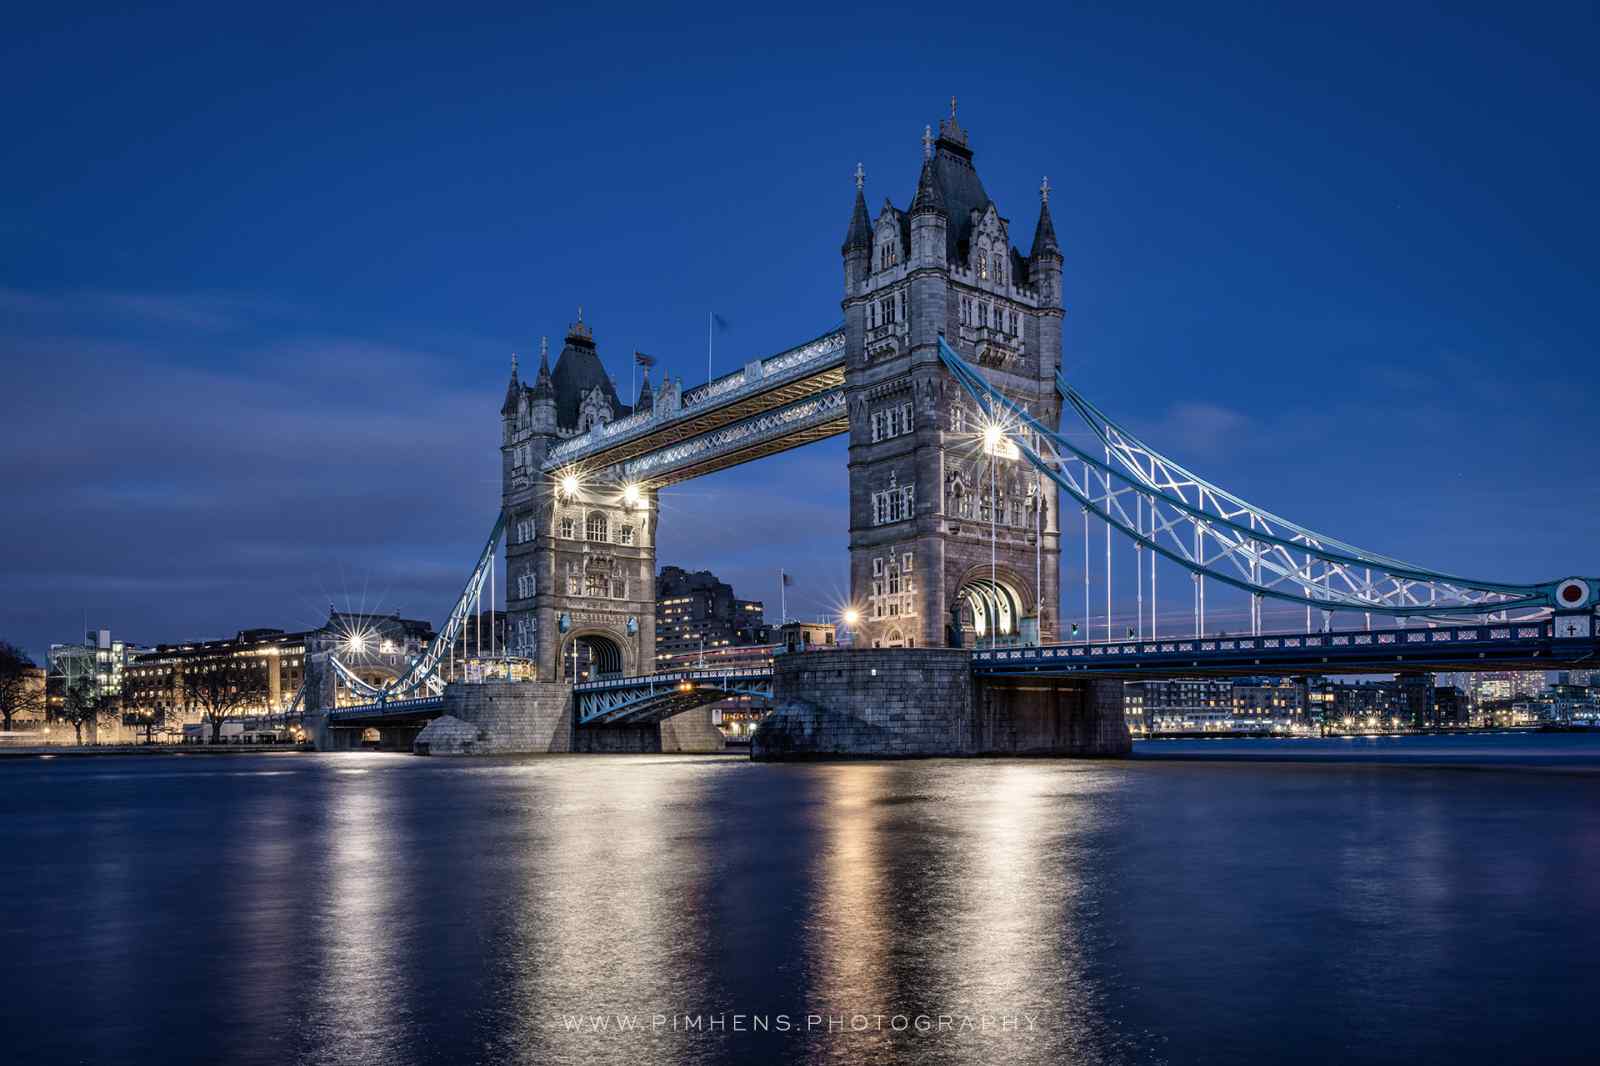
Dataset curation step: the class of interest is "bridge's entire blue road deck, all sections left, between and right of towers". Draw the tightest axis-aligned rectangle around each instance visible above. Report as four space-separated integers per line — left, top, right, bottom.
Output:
328 619 1600 727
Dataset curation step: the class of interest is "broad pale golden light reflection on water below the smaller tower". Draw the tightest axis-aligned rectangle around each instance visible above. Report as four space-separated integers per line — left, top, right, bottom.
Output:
507 755 717 1063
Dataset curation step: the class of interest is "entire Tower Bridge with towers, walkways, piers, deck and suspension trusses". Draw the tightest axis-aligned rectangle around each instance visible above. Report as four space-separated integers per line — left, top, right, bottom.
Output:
297 107 1600 757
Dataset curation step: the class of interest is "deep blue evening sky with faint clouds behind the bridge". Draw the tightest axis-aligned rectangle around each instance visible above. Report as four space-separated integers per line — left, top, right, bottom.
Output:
0 5 1600 651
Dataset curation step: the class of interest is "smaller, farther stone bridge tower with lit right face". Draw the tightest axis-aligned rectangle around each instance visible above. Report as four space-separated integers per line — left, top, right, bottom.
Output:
501 311 656 680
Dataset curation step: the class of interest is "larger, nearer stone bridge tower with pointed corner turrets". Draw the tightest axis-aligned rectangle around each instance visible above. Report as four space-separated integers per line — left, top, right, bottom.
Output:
842 99 1062 647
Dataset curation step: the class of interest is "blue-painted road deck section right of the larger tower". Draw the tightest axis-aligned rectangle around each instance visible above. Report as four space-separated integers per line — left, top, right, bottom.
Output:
973 621 1600 679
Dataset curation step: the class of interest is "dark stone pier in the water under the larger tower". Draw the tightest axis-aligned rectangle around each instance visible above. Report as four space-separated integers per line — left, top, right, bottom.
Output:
750 648 1133 760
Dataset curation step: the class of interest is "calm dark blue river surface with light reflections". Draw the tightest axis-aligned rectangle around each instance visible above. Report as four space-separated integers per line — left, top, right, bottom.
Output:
0 736 1600 1064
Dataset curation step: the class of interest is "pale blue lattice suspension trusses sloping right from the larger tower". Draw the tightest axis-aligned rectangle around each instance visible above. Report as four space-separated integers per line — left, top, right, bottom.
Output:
939 336 1587 623
